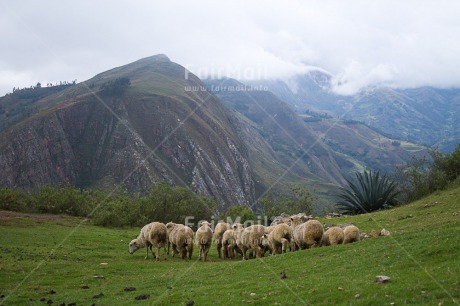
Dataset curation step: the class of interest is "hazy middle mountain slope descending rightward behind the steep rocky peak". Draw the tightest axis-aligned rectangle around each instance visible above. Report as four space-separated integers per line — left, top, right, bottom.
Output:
204 79 426 186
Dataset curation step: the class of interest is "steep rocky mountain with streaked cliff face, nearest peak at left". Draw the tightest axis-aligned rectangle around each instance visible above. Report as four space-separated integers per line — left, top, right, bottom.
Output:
0 55 255 210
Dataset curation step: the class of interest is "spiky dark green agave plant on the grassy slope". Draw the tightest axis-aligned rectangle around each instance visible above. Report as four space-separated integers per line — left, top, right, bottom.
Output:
337 170 400 214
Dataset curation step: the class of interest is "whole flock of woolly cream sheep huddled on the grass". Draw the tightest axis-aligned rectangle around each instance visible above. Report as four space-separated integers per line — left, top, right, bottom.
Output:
129 216 360 261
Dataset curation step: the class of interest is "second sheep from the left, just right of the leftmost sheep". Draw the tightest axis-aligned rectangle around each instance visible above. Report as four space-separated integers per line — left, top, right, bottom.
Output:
166 222 193 259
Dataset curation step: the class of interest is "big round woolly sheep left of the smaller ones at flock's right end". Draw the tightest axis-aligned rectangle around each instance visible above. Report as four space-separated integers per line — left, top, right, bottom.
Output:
291 216 324 250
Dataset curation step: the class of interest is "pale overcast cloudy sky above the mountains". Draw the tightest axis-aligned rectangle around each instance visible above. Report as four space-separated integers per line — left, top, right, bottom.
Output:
0 0 460 95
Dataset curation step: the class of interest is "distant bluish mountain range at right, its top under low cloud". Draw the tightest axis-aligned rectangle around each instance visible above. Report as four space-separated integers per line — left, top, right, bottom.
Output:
251 70 460 152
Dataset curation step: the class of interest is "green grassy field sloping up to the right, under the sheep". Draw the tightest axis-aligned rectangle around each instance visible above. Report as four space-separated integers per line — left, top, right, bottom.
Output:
0 184 460 305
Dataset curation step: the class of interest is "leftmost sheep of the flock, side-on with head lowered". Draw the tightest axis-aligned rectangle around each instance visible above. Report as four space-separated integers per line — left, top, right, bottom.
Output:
129 222 168 261
